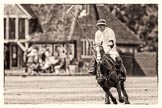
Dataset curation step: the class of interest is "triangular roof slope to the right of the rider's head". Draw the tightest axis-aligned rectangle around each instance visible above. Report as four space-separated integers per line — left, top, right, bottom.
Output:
97 7 141 44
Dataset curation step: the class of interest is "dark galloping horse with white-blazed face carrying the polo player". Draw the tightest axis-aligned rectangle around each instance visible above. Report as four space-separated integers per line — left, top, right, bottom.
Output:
93 45 130 104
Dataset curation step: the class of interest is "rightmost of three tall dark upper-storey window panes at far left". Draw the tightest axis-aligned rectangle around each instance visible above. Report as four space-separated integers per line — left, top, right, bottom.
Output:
18 18 25 39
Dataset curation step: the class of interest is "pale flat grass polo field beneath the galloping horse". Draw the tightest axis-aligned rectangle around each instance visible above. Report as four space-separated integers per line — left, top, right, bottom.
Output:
4 76 158 105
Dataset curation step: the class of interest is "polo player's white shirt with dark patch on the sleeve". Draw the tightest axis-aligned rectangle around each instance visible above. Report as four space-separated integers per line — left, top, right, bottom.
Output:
95 27 119 58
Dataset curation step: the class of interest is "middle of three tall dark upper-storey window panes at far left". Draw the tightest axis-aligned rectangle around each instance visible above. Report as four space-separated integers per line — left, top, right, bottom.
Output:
9 18 16 39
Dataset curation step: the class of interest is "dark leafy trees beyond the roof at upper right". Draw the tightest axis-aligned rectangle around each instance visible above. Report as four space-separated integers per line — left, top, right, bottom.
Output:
109 4 158 51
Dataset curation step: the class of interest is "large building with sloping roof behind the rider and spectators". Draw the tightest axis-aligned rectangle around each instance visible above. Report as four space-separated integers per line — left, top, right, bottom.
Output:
4 4 158 74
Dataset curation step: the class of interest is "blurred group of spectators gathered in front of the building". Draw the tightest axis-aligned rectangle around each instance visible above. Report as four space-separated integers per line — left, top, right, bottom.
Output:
26 46 66 72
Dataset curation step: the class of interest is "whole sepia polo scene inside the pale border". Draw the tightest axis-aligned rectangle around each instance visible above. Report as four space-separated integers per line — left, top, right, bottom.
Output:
3 3 159 105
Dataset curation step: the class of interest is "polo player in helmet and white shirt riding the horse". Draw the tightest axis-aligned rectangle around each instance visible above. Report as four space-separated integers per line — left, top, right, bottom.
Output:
89 19 126 79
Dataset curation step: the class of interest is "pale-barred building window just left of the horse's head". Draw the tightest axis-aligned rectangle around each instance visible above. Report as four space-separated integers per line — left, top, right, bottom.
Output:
81 39 94 58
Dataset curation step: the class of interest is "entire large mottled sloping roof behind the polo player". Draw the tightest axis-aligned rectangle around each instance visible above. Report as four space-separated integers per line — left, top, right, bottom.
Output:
22 4 141 45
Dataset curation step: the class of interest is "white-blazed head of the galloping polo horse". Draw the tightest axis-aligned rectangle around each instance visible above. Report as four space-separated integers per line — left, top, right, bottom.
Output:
94 44 105 61
